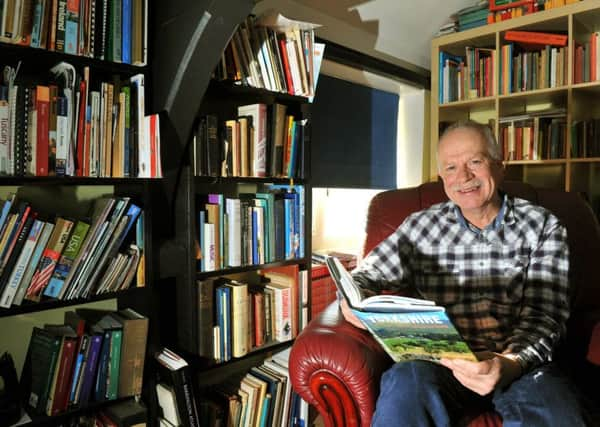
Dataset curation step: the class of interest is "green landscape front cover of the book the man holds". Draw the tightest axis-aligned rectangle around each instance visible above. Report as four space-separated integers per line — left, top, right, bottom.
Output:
352 310 477 362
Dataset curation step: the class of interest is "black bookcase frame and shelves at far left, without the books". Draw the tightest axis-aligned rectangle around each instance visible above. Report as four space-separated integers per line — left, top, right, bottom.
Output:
0 1 161 425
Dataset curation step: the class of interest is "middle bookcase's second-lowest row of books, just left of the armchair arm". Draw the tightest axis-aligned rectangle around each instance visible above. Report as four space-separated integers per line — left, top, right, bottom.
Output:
197 265 308 362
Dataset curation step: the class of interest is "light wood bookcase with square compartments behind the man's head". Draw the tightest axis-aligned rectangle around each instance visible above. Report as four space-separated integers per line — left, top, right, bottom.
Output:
429 0 600 213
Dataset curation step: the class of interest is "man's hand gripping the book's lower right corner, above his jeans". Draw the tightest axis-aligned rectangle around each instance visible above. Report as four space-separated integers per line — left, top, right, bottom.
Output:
440 354 522 396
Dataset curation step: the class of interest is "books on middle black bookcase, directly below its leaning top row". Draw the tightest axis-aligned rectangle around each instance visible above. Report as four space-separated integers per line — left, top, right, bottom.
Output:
192 103 306 178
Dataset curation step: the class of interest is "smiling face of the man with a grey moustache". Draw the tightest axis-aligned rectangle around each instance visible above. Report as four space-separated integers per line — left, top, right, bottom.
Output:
438 128 503 215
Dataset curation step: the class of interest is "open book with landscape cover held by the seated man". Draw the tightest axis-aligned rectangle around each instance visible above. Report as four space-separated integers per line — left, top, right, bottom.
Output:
326 257 477 362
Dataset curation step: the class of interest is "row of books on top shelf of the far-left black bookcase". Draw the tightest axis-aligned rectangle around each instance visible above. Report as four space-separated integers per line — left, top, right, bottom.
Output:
0 0 148 66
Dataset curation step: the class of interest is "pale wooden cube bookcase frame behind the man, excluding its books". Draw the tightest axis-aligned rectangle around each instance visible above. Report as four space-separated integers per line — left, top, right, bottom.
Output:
429 0 600 212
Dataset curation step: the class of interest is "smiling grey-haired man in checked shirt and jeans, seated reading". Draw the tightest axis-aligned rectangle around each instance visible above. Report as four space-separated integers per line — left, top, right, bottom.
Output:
342 122 585 427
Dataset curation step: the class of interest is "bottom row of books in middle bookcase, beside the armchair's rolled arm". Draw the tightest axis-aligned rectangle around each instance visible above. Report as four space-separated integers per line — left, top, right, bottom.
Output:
198 351 308 427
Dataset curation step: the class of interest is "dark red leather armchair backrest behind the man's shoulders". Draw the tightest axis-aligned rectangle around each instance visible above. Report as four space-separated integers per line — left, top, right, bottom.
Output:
363 181 600 362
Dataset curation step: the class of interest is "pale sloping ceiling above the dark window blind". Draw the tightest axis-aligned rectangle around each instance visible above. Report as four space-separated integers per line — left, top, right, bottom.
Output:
255 0 477 72
